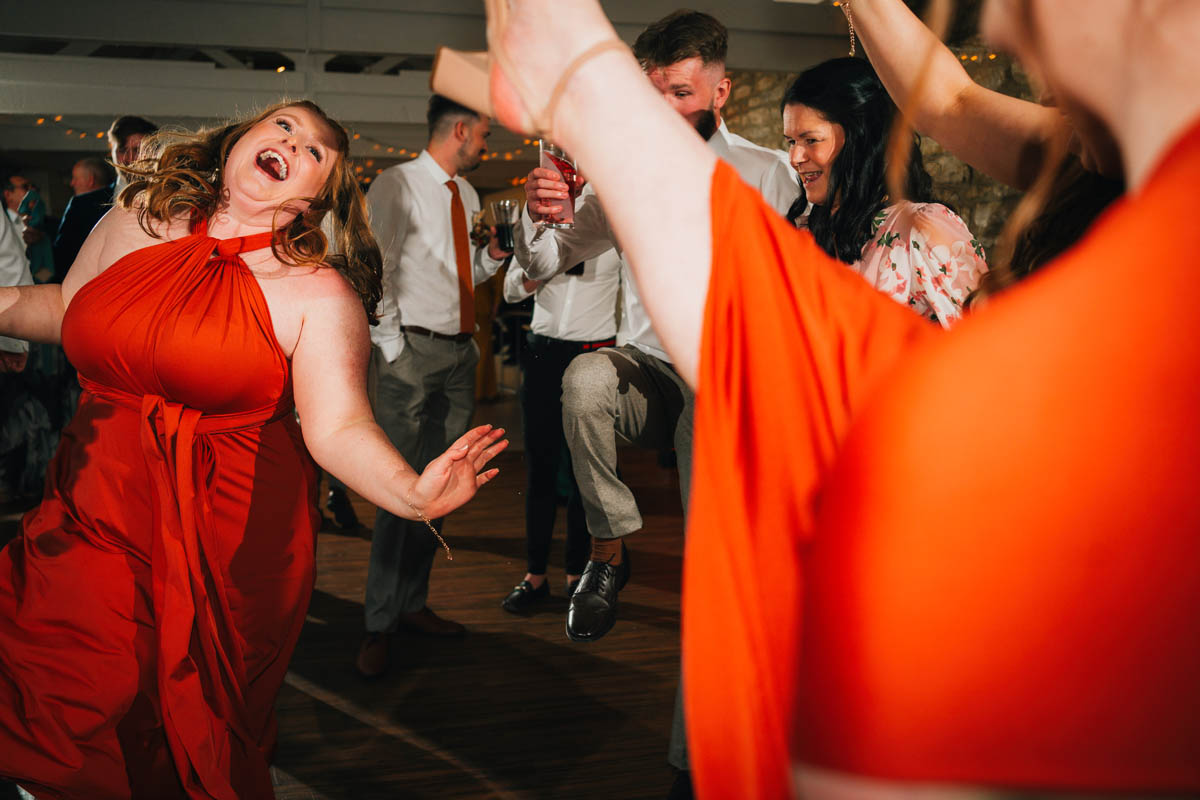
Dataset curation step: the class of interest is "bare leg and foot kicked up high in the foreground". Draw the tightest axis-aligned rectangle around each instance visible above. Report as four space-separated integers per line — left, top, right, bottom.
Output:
492 0 716 385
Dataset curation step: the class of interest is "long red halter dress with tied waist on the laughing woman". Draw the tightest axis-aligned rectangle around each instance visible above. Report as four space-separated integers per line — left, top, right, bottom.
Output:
0 221 318 800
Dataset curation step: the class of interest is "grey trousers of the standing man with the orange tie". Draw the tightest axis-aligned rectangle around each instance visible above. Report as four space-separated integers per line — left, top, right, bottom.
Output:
362 335 479 632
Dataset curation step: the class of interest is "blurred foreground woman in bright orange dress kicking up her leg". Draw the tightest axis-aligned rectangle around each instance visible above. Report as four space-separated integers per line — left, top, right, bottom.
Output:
436 0 1200 798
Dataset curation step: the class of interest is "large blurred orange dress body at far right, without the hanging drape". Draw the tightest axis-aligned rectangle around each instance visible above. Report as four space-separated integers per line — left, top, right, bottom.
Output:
796 120 1200 796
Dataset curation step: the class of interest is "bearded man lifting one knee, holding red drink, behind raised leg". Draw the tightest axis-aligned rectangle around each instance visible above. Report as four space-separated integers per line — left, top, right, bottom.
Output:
516 11 799 782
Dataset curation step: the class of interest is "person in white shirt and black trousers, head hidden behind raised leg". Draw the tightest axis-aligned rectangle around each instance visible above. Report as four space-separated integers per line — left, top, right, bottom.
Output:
502 249 620 614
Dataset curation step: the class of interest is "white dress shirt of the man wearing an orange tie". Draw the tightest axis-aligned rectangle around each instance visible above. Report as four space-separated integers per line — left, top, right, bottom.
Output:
367 150 504 361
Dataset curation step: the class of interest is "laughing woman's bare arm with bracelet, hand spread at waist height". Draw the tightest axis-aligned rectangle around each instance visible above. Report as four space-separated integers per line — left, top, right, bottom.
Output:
292 270 508 519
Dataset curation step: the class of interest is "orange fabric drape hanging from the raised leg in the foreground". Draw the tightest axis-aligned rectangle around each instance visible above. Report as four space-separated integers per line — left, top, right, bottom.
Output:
683 163 938 798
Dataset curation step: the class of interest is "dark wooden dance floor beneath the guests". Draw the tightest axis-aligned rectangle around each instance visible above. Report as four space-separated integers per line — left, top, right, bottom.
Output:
0 399 683 800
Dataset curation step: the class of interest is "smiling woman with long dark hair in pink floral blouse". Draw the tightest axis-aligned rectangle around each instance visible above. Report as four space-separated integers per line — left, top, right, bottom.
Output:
780 59 988 325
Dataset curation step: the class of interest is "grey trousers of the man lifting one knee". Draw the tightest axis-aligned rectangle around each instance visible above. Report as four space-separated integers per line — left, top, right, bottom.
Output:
563 344 696 770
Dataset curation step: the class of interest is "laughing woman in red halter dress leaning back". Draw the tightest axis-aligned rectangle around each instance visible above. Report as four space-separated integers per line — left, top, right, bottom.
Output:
0 102 504 800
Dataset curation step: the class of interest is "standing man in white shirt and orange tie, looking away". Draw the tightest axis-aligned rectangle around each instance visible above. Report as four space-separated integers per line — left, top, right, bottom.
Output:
356 95 508 676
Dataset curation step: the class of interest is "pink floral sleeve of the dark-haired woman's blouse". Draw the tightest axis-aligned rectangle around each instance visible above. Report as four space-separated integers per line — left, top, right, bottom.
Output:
852 201 988 327
